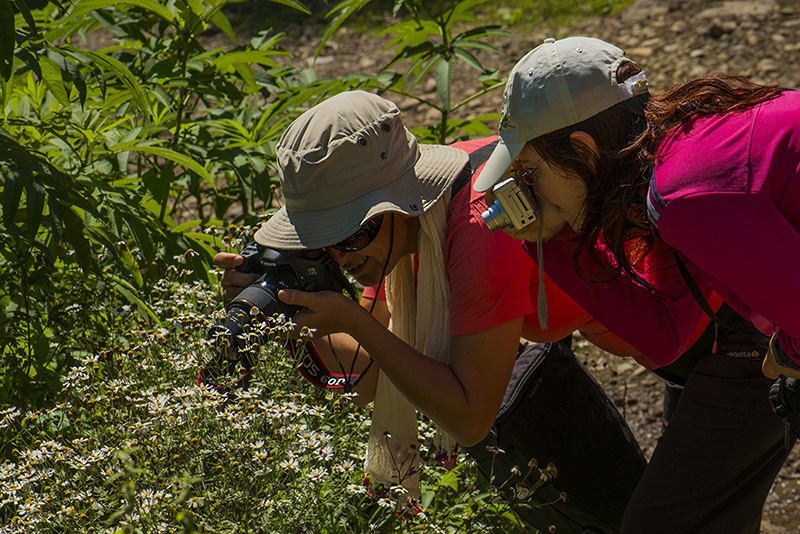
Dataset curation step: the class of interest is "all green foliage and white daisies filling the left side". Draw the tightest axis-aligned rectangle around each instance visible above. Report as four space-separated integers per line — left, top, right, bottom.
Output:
0 0 624 534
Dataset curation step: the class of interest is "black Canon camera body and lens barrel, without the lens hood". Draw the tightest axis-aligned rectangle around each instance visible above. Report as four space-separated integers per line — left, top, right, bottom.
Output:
225 242 356 348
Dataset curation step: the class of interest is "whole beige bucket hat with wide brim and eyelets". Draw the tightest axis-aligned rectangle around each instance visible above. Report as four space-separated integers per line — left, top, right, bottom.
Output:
255 91 469 250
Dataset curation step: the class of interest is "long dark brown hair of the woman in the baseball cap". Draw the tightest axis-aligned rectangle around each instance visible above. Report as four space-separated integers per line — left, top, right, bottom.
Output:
528 68 781 287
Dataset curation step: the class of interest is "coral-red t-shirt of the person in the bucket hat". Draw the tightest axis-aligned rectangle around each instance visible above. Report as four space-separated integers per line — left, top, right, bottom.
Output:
364 137 652 368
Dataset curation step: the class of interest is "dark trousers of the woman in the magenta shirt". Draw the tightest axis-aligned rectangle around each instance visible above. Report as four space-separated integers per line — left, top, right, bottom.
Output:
622 312 789 534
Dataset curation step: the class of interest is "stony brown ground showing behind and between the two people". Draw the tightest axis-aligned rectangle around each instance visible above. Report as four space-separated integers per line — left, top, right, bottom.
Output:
260 0 800 534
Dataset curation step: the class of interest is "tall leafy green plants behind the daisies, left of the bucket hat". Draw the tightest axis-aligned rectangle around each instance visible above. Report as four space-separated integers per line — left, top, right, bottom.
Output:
0 0 363 406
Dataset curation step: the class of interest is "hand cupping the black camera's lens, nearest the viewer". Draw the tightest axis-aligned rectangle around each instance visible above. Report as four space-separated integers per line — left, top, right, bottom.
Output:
278 289 369 339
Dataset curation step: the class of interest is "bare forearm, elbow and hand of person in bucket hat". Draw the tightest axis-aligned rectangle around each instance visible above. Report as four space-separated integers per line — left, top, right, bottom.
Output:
278 291 523 445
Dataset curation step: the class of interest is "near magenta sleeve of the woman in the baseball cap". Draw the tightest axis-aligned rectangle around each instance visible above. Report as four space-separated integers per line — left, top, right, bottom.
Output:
658 193 800 363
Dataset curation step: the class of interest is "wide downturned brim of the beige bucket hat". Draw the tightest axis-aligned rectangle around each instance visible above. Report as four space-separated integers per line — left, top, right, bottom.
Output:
255 144 469 250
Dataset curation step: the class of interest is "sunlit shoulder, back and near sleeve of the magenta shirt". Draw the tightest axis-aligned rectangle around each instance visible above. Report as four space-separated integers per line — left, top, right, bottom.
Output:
649 91 800 363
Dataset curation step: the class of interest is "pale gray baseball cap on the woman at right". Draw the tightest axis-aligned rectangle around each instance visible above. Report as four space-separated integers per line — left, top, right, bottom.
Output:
474 37 647 191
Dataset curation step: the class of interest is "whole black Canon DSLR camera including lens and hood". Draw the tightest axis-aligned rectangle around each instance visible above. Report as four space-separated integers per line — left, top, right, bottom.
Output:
197 242 357 389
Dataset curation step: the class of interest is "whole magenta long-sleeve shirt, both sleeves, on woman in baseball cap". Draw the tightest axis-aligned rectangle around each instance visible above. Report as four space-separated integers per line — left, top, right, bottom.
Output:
526 92 800 365
